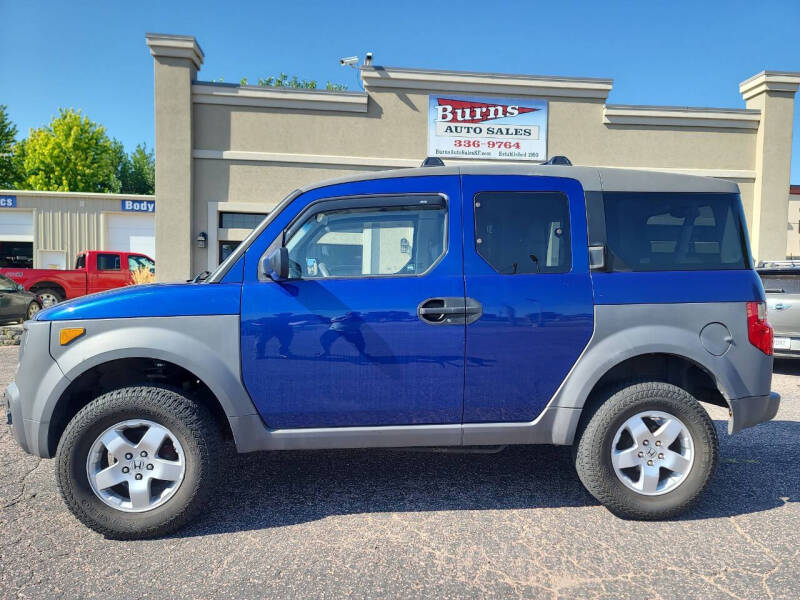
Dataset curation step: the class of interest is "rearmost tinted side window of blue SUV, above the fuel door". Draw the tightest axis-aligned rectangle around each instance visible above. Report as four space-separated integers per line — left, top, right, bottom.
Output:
603 192 750 271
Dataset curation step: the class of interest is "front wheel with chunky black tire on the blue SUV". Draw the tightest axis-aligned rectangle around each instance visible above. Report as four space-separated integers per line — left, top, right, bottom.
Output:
56 385 224 540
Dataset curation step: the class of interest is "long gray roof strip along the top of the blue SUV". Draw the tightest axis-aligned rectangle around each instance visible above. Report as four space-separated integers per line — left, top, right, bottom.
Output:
300 164 739 193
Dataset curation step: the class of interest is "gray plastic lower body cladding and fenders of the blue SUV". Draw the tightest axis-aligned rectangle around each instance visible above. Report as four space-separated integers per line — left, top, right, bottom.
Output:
7 303 779 456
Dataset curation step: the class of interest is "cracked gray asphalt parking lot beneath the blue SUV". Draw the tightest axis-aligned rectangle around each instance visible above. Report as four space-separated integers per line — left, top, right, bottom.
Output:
0 347 800 599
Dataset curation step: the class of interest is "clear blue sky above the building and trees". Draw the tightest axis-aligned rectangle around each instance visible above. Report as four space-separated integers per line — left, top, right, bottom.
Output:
0 0 800 183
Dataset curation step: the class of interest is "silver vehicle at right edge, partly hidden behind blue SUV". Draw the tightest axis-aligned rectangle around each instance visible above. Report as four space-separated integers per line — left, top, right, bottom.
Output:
758 261 800 358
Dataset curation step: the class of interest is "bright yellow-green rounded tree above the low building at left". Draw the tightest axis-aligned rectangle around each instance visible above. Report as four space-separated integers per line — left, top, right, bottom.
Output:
15 108 124 192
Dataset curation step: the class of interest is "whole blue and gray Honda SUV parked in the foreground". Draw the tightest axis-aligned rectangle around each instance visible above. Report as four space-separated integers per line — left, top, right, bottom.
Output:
6 165 780 539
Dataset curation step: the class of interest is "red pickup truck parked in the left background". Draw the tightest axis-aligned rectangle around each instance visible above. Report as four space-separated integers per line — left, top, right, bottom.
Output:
0 250 155 307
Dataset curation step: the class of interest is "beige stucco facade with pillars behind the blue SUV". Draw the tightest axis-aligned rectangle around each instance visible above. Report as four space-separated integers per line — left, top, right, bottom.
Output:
146 34 800 280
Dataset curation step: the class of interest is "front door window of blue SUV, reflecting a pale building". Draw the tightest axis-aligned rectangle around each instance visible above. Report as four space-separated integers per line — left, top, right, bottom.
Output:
286 204 445 279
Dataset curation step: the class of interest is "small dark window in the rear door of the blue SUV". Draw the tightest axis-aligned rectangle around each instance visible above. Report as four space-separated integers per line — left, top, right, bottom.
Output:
475 192 572 275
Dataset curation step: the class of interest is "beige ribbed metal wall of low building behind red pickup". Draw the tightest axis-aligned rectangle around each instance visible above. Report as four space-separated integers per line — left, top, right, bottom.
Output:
0 190 154 268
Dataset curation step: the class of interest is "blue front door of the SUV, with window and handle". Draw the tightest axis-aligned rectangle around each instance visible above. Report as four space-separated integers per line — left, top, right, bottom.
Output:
241 177 465 429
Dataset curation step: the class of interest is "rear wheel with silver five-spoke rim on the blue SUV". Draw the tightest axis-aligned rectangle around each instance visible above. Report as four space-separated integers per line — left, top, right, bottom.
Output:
574 382 719 520
